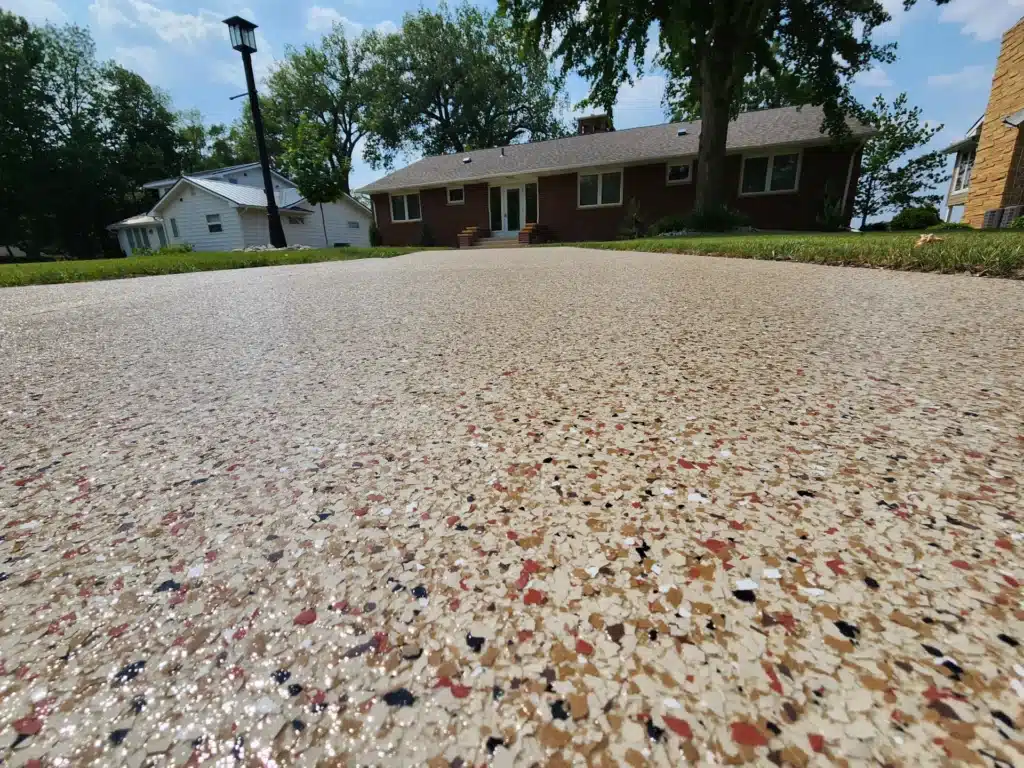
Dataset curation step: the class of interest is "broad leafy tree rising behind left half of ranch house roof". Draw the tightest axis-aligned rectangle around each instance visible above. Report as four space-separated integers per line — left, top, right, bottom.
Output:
366 3 566 167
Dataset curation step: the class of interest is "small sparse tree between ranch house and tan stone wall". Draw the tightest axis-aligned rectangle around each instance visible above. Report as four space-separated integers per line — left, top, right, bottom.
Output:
853 93 949 226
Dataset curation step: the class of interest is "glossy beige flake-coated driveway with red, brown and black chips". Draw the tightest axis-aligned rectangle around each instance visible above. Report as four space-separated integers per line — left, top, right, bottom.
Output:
0 249 1024 766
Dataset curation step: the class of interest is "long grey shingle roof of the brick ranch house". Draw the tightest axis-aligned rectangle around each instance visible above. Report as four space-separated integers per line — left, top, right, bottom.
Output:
357 106 876 193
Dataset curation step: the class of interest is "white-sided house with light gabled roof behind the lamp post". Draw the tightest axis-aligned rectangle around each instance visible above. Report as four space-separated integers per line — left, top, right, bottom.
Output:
108 163 373 256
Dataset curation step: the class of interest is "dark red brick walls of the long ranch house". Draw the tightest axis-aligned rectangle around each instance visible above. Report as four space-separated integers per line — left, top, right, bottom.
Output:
373 145 860 247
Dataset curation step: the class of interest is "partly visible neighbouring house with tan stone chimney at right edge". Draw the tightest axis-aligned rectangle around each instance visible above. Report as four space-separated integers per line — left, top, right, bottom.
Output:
943 18 1024 228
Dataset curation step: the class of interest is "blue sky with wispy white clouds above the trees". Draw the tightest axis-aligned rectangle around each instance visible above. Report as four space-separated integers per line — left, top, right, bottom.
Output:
6 0 1024 196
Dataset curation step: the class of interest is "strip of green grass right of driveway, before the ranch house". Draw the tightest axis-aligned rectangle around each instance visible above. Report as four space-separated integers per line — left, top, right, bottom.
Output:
579 229 1024 280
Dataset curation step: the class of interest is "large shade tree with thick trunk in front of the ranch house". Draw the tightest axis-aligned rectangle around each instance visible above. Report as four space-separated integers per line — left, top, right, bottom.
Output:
499 0 913 212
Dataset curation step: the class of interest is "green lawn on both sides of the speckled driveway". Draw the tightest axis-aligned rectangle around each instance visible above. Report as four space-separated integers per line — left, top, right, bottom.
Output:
0 230 1024 288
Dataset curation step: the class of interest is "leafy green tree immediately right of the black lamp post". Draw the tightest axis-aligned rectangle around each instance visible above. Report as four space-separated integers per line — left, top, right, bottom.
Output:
267 25 374 200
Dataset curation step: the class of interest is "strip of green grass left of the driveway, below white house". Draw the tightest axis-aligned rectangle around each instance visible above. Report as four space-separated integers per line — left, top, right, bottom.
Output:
0 248 432 288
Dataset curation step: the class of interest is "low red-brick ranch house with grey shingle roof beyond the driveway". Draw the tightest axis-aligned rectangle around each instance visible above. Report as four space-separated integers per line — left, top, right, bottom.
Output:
358 106 874 247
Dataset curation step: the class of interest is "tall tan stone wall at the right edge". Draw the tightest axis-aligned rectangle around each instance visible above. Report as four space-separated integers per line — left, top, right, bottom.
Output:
964 18 1024 226
